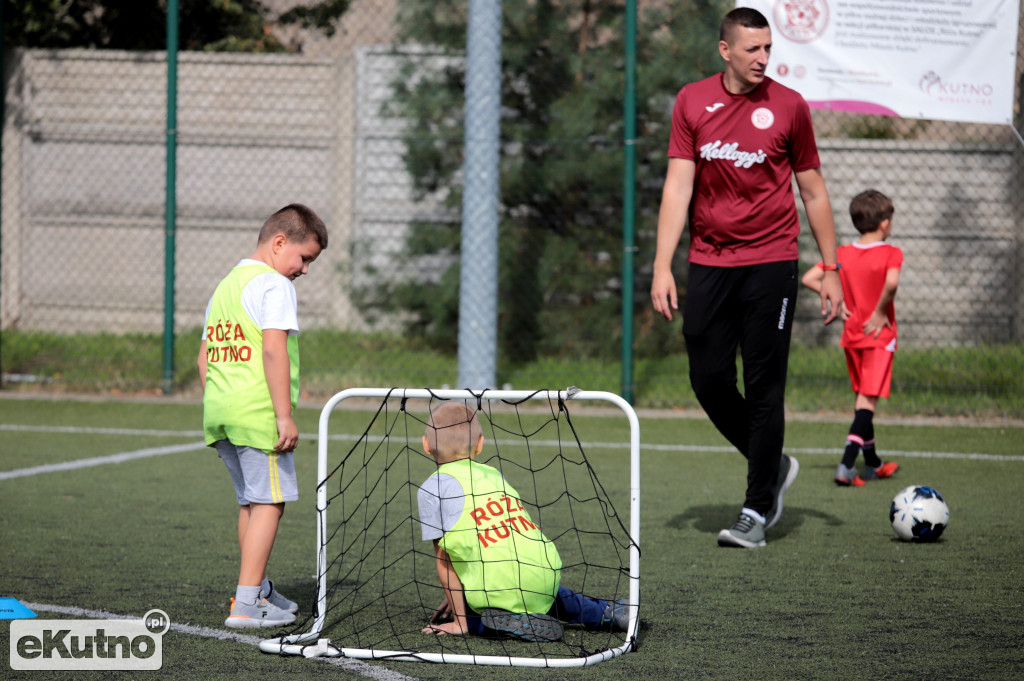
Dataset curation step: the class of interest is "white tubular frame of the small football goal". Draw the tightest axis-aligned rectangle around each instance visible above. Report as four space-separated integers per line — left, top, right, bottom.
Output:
259 388 640 668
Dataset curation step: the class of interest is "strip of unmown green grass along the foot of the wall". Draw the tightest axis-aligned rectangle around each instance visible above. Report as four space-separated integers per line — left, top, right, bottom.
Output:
0 330 1024 419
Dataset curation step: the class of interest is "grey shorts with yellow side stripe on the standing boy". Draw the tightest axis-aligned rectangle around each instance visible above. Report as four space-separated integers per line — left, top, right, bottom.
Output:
213 439 299 506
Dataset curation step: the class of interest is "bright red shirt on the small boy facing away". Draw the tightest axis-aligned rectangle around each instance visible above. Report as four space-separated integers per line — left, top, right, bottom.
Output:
838 242 903 350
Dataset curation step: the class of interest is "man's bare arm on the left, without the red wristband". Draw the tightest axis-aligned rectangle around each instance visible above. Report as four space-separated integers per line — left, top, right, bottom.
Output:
650 159 696 321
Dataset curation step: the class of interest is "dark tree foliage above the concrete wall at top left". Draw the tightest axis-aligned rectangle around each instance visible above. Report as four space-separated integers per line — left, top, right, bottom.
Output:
2 0 351 52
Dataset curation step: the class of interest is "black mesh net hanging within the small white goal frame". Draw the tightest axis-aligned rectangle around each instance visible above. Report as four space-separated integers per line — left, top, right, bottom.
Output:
292 396 636 659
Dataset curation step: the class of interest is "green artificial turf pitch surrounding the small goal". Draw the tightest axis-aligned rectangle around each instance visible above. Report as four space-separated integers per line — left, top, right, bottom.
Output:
0 398 1024 681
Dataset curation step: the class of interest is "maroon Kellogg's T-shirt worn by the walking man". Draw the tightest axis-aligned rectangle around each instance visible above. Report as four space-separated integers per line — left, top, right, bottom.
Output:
669 74 821 267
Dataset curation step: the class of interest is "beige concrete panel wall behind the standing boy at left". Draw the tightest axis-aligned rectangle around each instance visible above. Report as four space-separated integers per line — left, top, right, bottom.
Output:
0 50 354 331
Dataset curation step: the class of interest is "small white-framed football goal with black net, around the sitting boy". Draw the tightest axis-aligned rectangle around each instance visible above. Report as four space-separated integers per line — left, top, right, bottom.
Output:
260 388 640 667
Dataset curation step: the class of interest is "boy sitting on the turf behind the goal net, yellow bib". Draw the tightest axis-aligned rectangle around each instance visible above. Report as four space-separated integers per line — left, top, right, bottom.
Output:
417 401 629 641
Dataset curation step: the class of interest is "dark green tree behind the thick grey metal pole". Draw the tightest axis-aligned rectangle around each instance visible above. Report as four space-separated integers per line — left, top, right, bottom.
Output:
357 0 731 363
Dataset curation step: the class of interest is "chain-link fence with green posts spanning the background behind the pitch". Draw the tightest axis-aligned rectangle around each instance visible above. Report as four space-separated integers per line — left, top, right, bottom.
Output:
0 0 1024 418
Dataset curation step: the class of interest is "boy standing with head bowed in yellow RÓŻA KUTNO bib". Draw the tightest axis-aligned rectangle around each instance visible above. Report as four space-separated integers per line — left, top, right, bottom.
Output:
198 204 327 628
